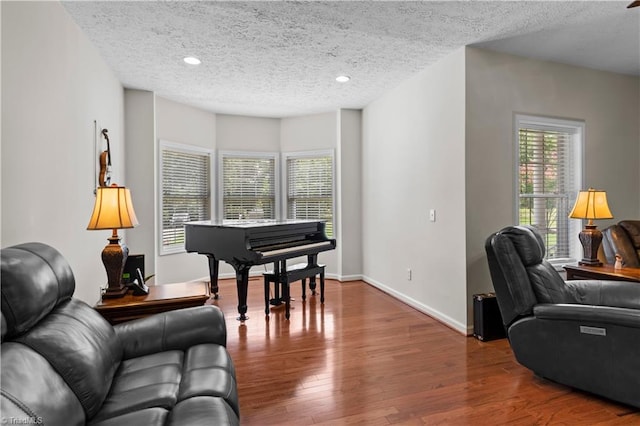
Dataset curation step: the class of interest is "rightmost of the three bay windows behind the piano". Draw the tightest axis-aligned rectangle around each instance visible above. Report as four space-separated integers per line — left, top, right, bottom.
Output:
285 151 334 237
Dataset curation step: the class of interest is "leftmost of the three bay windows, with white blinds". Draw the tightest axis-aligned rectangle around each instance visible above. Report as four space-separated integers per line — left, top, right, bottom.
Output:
160 141 211 254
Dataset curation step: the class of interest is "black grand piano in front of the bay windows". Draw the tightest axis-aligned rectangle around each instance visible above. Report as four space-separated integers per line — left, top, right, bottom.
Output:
184 220 336 321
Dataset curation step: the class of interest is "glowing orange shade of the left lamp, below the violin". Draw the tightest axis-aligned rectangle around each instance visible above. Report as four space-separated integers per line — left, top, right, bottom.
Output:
87 185 138 230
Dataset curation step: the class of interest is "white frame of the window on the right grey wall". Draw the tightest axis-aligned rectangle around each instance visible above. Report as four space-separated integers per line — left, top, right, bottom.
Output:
513 113 586 268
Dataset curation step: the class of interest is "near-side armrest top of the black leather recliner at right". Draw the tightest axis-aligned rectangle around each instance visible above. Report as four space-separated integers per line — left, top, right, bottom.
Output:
533 303 640 328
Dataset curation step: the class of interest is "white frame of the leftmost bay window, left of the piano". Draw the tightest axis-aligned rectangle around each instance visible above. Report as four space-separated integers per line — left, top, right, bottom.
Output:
158 139 215 256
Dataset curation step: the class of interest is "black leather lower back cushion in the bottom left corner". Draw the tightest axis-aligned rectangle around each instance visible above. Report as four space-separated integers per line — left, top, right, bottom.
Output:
0 342 85 426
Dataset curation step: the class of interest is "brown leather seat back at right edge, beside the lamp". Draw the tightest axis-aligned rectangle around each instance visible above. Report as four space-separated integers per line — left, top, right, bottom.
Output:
602 220 640 268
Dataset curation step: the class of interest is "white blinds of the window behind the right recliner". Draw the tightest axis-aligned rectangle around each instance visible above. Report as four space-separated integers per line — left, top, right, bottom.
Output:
518 127 579 258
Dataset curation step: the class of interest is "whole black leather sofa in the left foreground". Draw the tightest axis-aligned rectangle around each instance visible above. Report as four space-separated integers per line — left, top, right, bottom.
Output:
0 243 239 426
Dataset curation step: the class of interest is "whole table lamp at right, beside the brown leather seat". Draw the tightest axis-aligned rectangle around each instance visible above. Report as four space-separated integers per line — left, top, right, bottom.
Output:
569 188 613 266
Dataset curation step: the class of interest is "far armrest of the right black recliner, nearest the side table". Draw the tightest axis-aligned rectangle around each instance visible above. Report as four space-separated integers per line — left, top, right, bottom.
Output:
566 280 640 309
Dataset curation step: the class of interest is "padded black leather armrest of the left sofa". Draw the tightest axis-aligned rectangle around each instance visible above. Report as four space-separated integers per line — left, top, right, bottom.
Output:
113 305 227 359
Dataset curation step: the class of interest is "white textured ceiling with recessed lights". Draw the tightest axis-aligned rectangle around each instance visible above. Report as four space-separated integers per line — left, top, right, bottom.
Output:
62 0 640 117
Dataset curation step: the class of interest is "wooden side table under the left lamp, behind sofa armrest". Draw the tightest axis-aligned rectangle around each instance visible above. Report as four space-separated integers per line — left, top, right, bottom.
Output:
94 282 210 324
